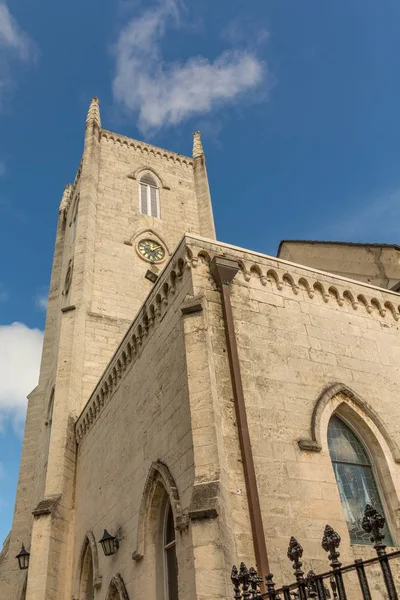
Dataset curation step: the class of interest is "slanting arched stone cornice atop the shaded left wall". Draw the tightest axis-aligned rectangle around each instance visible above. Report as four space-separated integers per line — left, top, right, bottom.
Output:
75 251 191 443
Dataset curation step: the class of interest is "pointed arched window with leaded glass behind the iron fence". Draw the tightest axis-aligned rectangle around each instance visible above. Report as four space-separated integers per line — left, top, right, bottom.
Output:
328 416 392 545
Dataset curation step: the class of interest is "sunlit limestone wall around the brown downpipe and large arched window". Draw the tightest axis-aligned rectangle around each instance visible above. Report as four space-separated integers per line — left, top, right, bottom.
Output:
186 241 400 598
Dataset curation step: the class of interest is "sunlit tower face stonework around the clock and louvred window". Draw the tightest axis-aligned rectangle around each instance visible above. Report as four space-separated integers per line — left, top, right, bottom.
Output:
83 130 212 398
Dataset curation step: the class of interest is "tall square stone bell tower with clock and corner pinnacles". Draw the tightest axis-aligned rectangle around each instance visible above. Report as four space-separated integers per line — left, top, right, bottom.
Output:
0 98 215 600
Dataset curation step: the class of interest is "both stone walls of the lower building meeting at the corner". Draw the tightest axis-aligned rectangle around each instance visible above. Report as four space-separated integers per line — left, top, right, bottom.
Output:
70 236 400 599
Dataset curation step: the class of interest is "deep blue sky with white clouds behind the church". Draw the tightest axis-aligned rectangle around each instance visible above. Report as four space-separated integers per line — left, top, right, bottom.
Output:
0 0 400 544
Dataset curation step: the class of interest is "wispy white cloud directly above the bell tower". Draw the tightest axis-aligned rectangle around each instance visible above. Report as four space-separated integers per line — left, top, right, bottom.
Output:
113 0 266 132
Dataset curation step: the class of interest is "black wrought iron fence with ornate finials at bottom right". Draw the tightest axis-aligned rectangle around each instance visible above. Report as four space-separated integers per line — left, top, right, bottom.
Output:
231 504 400 600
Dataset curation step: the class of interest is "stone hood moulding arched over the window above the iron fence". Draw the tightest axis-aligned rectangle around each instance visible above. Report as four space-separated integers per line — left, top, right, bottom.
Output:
298 383 400 463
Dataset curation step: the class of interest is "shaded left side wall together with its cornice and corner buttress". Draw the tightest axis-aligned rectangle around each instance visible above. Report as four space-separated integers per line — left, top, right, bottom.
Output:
73 239 248 600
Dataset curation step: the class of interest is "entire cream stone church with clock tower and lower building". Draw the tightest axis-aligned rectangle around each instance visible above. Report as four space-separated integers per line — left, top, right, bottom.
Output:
0 98 400 600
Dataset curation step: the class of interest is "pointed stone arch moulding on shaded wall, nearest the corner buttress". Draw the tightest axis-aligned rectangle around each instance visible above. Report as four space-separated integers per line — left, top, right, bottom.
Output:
132 461 188 561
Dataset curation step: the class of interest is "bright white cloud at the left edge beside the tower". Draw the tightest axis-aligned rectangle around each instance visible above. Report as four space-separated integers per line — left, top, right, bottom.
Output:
0 322 43 429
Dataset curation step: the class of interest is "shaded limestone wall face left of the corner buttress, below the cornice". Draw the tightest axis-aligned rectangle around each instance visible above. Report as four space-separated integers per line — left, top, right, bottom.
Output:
74 262 194 598
